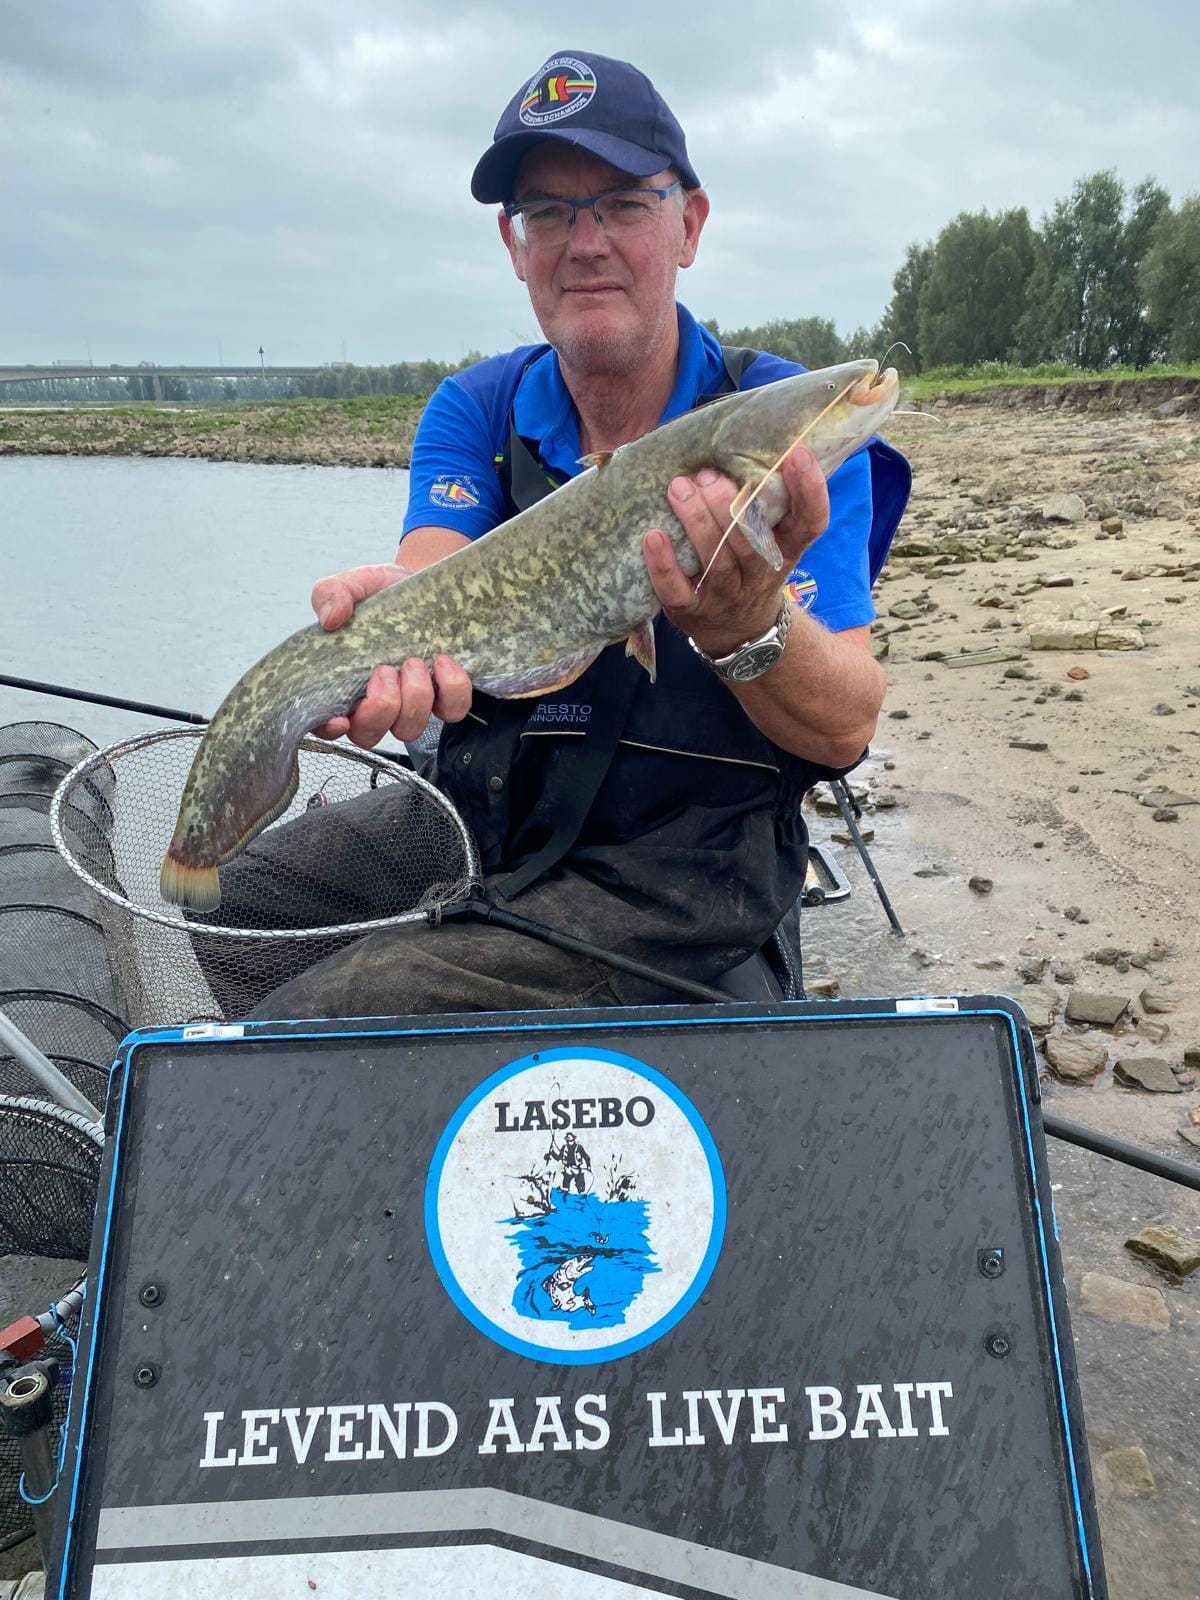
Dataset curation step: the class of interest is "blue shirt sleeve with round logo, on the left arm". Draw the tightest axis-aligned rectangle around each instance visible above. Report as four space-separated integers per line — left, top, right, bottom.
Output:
400 378 506 539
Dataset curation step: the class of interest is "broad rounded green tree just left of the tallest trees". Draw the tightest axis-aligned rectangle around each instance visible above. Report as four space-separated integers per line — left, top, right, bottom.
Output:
917 208 1035 366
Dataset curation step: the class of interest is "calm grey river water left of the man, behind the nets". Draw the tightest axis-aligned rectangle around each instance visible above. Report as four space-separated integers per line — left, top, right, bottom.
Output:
0 456 408 744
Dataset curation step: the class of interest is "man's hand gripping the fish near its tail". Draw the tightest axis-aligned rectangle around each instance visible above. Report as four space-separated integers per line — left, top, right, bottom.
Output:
312 562 470 750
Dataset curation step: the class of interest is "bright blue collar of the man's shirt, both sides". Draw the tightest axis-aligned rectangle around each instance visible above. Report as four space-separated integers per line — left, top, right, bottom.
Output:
512 304 725 477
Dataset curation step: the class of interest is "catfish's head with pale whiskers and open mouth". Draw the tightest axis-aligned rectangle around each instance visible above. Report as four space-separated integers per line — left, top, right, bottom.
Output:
712 362 899 482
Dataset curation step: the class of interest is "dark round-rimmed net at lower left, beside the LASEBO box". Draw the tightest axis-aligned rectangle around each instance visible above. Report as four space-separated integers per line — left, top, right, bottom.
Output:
0 1096 101 1546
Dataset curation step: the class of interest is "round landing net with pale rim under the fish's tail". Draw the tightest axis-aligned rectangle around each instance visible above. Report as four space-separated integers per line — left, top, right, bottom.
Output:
50 728 478 1027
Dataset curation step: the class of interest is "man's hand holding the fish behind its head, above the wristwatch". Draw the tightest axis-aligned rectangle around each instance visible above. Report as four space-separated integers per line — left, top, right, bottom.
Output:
643 445 829 656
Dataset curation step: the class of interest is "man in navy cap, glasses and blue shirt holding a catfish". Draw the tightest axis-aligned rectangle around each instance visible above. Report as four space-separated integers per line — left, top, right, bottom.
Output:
236 53 909 1016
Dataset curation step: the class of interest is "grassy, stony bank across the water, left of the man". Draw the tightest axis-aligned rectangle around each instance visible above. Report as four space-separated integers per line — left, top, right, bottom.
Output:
0 395 424 467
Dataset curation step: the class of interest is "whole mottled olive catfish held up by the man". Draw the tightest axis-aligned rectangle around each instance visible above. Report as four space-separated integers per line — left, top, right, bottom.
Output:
160 360 899 912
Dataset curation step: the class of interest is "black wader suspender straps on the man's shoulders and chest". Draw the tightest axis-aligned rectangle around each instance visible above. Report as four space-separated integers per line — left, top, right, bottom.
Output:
491 346 758 899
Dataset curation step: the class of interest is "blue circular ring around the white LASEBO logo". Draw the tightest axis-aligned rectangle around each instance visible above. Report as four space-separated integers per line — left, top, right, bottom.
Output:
426 1046 728 1366
